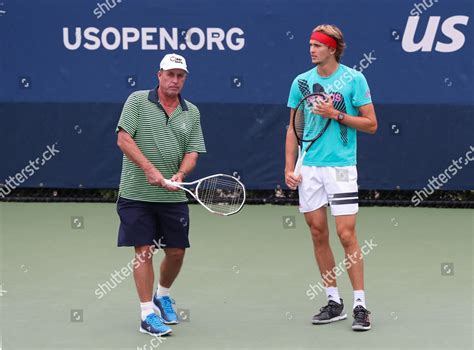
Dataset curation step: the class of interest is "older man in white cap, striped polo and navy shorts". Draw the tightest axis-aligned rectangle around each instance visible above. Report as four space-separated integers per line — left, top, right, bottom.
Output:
116 54 206 336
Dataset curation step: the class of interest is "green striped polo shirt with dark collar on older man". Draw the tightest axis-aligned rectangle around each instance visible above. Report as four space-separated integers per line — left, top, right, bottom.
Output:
116 88 206 203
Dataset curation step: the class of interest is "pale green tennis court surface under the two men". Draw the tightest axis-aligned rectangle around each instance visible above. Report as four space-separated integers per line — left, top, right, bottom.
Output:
0 203 474 350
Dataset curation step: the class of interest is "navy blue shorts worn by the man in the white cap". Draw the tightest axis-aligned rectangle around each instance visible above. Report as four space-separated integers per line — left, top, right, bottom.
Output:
117 197 190 248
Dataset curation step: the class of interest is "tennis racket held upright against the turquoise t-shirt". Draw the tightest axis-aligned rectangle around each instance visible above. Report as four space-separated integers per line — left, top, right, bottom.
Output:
292 92 331 176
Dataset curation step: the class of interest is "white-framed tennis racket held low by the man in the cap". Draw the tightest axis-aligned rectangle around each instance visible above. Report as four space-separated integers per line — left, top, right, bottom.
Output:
165 174 245 216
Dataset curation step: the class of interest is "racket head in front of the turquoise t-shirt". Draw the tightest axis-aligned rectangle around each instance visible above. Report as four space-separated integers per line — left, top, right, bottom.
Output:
292 92 330 145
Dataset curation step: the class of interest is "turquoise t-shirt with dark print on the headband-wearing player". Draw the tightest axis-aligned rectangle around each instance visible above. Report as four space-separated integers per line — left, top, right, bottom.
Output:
288 64 372 166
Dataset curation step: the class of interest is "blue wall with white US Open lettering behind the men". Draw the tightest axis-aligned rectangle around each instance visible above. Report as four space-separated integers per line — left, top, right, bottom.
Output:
0 0 474 189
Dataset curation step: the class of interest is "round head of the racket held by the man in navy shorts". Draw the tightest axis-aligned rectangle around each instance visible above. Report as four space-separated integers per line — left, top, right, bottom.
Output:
197 176 245 214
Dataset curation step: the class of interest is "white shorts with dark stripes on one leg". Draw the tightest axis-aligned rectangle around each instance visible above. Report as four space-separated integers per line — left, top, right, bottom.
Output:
298 165 359 216
